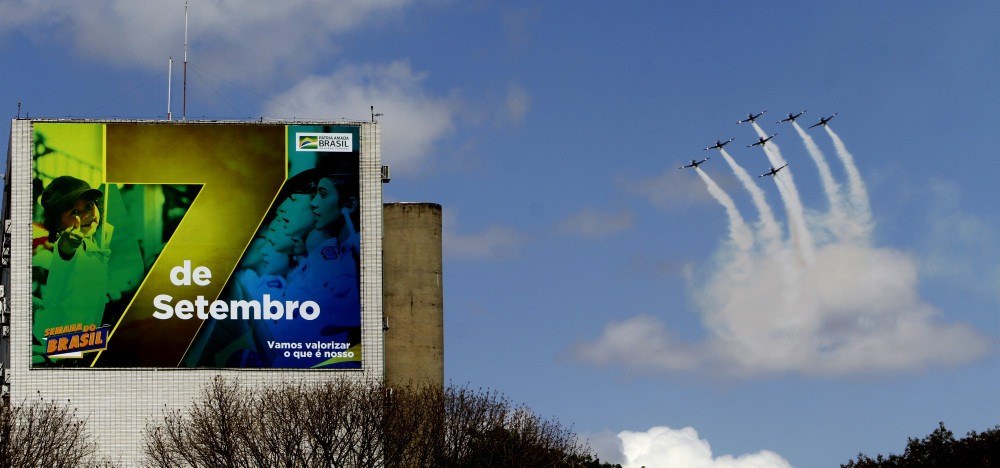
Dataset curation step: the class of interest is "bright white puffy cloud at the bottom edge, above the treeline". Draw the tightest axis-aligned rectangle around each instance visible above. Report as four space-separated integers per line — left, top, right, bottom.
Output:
598 426 792 468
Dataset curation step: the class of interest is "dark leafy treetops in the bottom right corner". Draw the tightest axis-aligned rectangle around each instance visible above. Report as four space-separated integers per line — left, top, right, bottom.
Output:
840 422 1000 468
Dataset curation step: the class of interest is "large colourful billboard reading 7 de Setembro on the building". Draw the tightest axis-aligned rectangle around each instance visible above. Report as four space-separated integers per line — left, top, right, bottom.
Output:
31 122 362 369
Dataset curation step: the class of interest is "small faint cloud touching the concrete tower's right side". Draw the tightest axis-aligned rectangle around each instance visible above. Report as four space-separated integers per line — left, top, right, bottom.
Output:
441 210 525 260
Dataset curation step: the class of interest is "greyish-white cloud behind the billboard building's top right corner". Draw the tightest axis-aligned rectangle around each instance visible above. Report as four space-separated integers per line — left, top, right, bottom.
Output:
264 61 456 170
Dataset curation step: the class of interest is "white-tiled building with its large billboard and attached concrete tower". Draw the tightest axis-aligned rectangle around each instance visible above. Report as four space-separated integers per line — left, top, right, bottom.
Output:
0 119 443 464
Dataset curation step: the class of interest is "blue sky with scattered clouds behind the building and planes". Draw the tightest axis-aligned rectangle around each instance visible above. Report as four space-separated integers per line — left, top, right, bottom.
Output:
0 0 1000 467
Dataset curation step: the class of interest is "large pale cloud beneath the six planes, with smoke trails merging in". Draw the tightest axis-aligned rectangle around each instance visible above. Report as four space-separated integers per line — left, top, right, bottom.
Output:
575 119 990 377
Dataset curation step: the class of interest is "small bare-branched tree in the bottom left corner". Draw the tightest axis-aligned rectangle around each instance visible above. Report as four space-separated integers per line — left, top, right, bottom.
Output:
0 399 120 468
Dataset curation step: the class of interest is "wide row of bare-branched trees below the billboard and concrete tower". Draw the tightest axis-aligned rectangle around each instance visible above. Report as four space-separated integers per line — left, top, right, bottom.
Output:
145 378 615 468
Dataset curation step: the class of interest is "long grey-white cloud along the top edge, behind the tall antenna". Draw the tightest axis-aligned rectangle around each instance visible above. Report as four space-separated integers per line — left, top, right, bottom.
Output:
0 0 409 80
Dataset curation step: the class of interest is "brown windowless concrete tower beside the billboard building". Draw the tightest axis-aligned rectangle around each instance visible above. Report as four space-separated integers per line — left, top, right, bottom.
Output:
382 203 444 386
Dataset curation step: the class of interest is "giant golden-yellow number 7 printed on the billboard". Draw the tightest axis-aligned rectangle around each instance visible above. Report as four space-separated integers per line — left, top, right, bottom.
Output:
91 123 287 367
